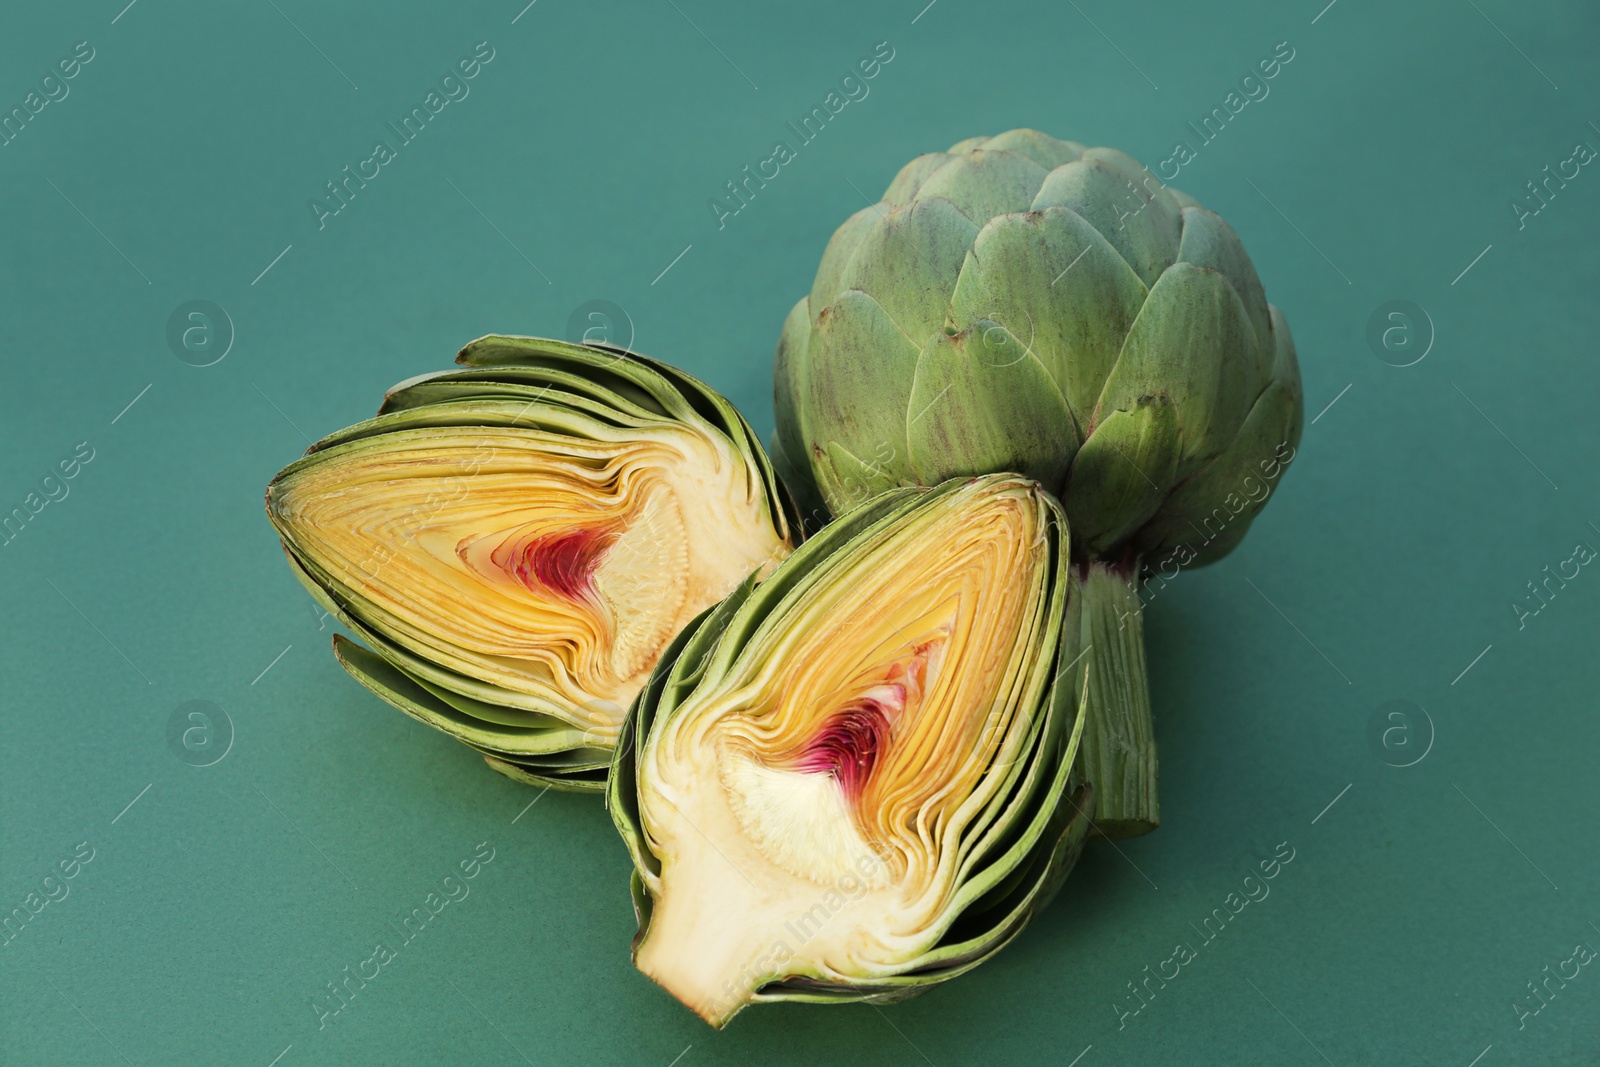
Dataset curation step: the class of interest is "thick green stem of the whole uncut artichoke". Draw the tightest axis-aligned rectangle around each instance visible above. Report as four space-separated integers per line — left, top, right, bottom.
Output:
1062 560 1162 838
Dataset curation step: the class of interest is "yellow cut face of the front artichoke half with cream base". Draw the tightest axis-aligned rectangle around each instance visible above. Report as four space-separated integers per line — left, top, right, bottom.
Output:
627 478 1070 1025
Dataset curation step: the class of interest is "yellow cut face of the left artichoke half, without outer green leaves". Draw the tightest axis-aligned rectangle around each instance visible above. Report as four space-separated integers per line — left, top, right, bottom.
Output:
269 415 787 744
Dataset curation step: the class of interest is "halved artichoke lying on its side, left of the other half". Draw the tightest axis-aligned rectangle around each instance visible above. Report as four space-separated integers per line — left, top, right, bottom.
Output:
267 336 797 790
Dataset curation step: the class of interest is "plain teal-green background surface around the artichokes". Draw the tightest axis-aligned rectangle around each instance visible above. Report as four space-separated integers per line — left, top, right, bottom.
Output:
0 0 1600 1067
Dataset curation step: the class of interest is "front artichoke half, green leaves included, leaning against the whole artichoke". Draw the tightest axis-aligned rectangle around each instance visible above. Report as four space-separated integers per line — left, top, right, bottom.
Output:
606 475 1093 1027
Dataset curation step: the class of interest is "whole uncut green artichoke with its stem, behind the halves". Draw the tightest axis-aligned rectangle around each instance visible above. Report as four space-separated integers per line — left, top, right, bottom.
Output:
774 130 1302 837
